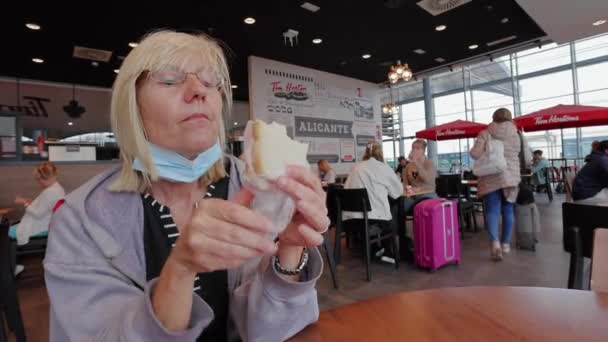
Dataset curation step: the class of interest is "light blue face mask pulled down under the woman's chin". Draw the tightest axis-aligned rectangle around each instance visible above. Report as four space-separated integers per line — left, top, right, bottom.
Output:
133 142 222 183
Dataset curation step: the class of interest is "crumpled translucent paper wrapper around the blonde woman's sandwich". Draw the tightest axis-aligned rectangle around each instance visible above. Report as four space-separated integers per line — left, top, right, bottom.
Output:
244 121 309 235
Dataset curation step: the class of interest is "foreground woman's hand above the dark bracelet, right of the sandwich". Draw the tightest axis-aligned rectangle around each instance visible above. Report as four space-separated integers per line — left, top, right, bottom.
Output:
276 166 330 268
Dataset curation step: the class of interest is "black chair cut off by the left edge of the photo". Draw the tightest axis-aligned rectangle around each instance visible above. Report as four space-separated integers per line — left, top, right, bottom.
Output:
0 220 25 342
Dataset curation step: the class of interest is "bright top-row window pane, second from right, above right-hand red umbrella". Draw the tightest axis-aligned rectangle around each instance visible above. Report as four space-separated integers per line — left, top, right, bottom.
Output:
517 44 571 75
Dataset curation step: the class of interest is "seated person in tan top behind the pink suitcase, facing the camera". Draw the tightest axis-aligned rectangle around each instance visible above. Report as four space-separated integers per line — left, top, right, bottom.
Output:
403 139 437 215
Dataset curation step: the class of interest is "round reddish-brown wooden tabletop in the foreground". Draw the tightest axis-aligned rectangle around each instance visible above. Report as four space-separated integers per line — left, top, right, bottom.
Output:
290 287 608 342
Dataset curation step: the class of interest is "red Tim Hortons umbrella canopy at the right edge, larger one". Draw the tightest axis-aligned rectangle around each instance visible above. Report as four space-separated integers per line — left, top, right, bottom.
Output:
513 105 608 132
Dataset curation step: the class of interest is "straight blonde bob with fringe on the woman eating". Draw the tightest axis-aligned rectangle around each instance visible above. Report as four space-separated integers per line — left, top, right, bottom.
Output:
110 30 232 192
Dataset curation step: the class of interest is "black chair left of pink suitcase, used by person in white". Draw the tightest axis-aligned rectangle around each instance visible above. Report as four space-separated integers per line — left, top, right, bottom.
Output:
334 189 399 281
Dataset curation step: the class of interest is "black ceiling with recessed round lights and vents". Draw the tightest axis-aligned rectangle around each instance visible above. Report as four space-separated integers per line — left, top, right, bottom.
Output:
0 0 545 100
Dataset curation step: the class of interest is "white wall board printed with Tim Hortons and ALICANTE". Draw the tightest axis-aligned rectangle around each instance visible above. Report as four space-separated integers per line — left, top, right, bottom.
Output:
249 56 382 174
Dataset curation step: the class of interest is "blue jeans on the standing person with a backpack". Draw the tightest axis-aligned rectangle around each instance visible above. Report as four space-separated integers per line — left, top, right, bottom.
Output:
483 190 515 243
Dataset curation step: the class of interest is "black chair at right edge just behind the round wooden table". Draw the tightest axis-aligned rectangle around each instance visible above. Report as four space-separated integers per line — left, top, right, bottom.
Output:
562 202 608 289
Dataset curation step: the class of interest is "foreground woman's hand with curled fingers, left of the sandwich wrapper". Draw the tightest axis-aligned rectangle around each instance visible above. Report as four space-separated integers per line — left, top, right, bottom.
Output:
170 189 276 273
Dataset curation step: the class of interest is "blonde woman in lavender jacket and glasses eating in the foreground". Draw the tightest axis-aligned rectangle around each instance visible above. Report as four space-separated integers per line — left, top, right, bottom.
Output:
45 31 329 341
